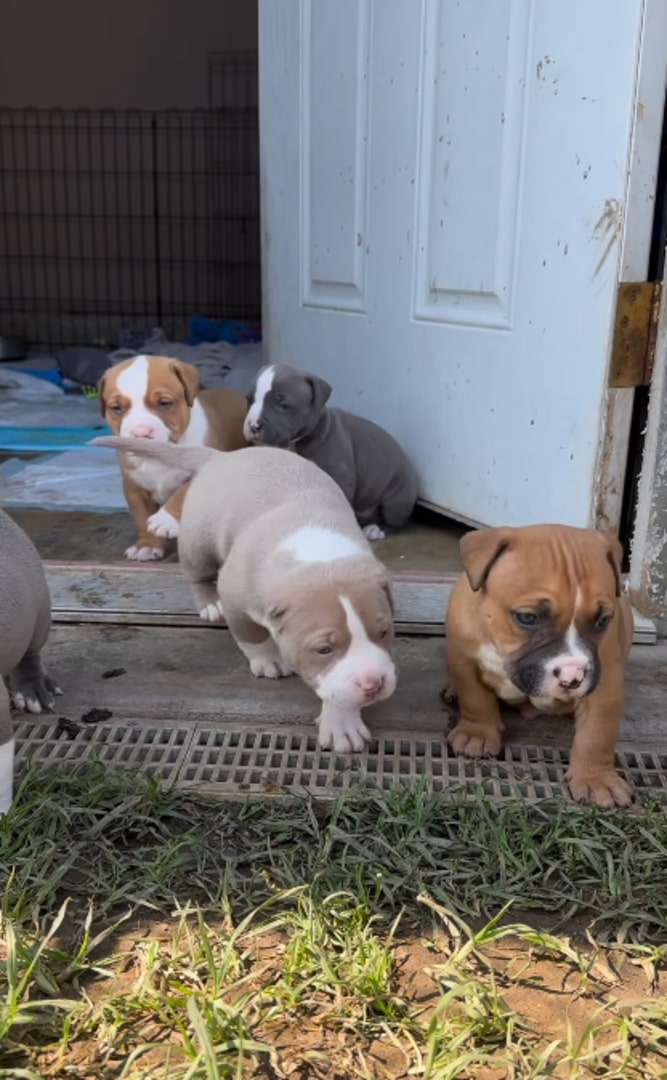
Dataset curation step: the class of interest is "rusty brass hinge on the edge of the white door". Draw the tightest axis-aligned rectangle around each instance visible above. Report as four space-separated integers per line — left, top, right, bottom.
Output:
609 281 663 387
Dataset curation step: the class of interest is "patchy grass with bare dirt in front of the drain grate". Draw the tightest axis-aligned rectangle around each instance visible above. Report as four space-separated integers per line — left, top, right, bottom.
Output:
0 766 667 1080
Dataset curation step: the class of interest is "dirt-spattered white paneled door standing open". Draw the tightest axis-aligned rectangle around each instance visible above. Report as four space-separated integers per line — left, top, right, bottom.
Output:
259 0 662 525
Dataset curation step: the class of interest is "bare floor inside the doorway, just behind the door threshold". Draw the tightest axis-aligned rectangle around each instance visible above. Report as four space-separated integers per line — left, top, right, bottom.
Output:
9 508 466 573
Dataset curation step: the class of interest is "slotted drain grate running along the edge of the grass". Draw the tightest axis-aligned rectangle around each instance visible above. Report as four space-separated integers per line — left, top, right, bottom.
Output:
16 718 667 802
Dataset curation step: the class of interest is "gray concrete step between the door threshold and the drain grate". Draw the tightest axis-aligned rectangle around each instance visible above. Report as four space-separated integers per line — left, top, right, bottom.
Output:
33 623 667 752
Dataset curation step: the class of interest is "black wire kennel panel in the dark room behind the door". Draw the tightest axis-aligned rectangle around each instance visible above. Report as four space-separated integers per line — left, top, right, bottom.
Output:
0 101 261 349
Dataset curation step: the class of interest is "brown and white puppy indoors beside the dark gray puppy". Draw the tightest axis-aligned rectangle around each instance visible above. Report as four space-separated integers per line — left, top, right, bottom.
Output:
99 356 247 562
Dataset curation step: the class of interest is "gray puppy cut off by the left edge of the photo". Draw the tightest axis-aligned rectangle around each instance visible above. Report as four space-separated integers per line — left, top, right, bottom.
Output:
0 510 60 813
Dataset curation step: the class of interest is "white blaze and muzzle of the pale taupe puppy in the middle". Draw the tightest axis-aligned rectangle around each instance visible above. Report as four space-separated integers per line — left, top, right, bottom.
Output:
314 596 396 708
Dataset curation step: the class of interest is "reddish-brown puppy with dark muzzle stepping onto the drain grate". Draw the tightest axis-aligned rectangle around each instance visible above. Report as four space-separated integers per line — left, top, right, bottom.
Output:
443 525 632 807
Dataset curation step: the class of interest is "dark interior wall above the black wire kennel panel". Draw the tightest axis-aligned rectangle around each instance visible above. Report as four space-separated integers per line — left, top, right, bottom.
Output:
0 0 257 109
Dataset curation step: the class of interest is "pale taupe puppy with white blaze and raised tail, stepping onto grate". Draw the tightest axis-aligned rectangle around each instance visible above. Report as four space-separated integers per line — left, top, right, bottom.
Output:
94 437 396 753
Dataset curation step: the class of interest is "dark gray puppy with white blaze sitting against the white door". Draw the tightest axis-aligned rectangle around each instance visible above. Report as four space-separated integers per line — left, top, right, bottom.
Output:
243 364 418 540
